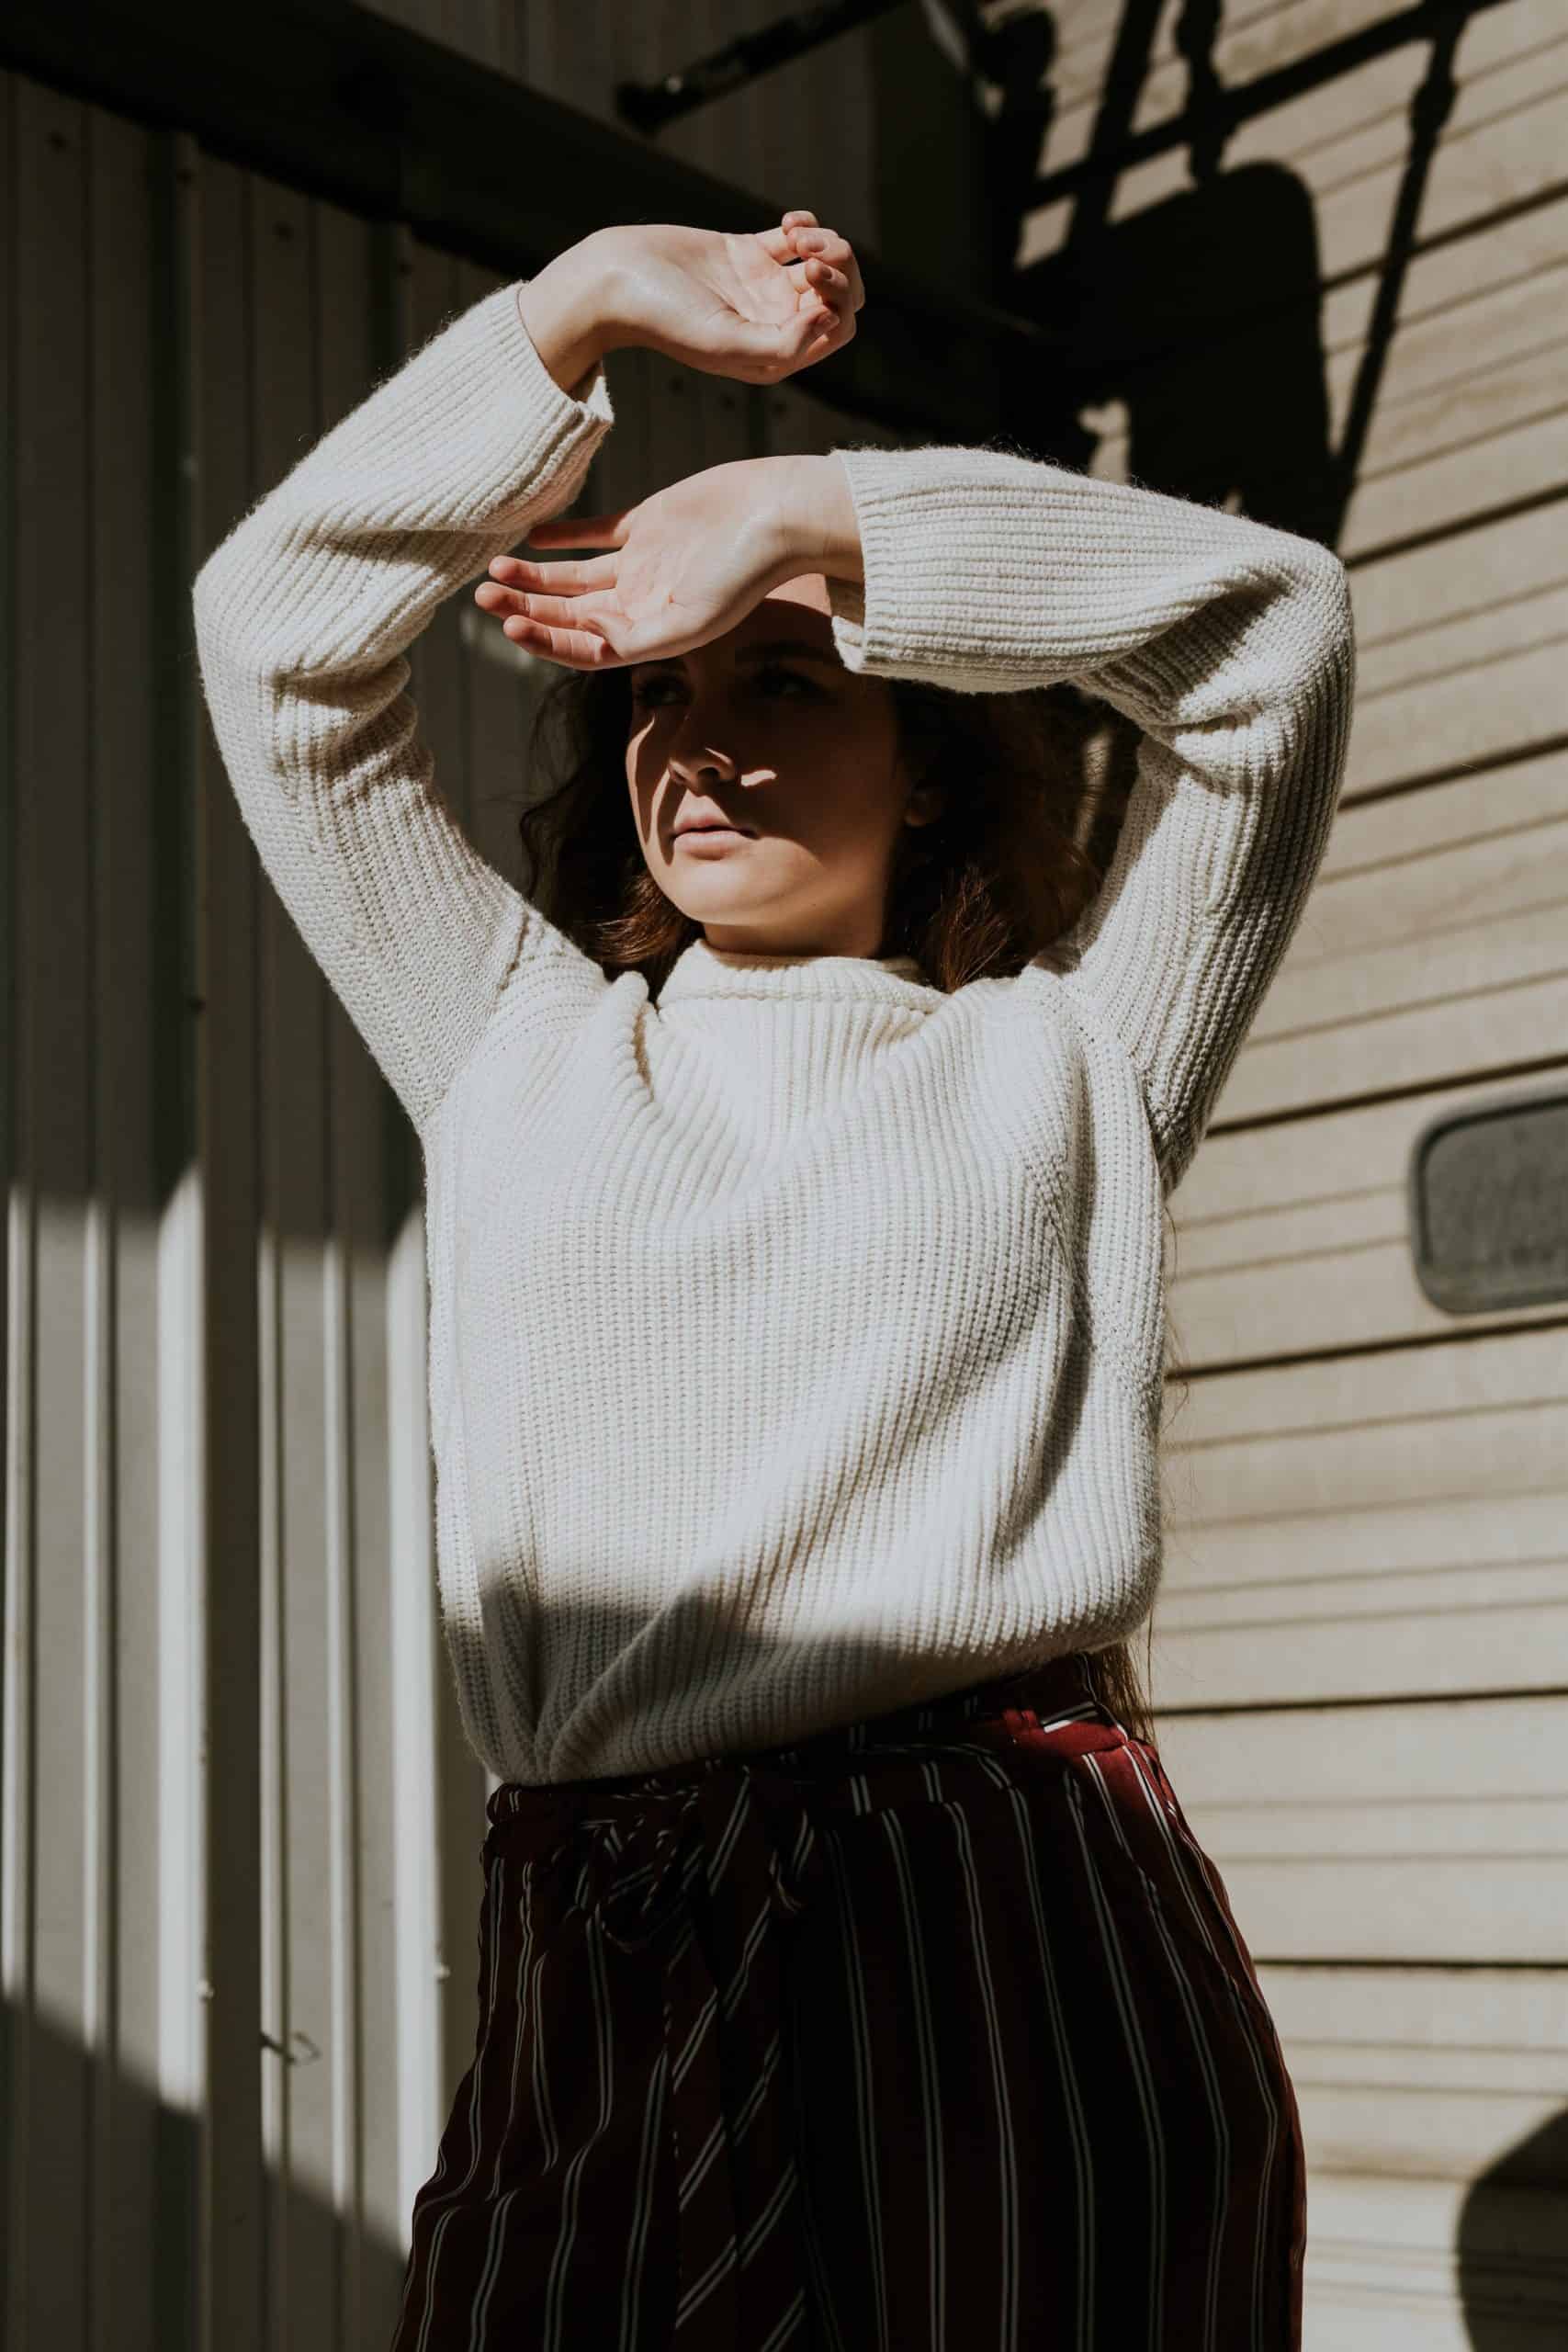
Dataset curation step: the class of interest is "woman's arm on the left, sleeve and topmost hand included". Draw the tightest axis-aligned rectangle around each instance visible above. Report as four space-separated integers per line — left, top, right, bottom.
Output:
193 214 858 1129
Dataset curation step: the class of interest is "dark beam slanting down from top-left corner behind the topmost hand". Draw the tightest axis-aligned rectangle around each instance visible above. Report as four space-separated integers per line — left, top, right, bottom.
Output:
0 0 1054 442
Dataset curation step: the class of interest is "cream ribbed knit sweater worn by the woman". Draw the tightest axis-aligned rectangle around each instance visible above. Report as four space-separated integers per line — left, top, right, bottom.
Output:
195 270 1352 1782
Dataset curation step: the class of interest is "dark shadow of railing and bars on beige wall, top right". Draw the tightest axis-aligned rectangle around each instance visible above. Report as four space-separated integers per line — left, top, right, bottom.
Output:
968 0 1485 546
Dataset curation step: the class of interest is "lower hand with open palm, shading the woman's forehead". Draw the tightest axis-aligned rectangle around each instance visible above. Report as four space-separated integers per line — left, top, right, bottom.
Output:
475 457 811 671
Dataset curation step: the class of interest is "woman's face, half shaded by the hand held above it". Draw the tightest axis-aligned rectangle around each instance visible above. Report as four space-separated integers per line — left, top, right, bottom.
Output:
626 574 941 957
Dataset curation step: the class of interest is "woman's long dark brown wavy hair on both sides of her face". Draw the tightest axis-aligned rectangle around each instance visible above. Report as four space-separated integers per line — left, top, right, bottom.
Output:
517 668 1189 1746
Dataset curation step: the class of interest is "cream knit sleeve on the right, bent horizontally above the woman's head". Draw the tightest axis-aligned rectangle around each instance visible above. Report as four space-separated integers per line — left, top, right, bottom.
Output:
828 449 1354 1193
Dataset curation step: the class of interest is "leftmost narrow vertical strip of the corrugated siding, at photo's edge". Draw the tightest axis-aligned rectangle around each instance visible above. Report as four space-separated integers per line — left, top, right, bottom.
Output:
7 68 94 2352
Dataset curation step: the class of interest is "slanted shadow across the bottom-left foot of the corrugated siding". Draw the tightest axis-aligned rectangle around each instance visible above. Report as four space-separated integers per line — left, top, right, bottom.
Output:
0 2004 404 2352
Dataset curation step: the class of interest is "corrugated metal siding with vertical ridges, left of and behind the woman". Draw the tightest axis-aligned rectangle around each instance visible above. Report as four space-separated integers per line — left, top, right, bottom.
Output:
0 64 911 2352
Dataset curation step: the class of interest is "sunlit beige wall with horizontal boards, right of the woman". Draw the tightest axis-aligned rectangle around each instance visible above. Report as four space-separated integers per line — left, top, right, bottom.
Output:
1001 0 1568 2352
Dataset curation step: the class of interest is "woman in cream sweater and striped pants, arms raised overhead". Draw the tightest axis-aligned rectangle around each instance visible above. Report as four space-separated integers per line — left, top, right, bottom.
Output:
195 211 1352 2352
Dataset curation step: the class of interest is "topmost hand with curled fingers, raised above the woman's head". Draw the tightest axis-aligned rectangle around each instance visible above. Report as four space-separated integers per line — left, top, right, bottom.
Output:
592 211 865 383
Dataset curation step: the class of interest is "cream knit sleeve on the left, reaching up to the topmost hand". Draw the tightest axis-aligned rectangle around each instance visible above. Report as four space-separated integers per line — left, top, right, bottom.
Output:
193 282 614 1129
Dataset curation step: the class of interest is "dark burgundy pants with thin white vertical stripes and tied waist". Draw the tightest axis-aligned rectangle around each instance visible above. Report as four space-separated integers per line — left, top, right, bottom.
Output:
392 1656 1307 2352
